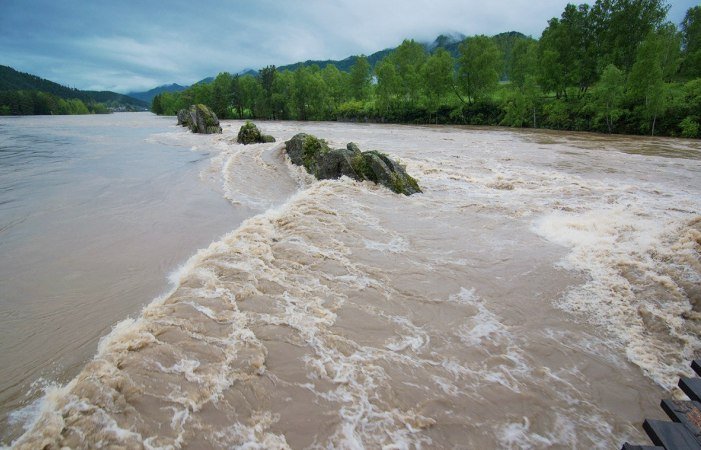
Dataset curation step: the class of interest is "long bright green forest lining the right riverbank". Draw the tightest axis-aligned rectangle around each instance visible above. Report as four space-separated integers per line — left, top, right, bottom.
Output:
152 0 701 137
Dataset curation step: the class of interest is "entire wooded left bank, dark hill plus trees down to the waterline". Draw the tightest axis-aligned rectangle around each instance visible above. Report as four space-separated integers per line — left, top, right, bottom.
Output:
0 66 147 115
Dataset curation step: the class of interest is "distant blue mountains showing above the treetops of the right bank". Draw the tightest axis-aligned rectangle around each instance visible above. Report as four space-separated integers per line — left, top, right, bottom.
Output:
127 31 528 103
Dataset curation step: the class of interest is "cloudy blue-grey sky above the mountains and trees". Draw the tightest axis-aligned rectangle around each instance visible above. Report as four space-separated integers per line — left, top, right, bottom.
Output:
0 0 697 92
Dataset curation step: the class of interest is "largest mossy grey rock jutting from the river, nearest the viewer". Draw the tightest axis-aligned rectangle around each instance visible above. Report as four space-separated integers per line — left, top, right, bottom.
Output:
285 133 421 195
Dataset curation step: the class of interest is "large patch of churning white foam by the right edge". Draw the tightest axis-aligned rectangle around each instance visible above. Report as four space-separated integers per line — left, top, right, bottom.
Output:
533 206 701 388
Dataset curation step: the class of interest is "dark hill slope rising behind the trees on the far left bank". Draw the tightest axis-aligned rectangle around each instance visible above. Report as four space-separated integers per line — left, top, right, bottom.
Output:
0 66 148 110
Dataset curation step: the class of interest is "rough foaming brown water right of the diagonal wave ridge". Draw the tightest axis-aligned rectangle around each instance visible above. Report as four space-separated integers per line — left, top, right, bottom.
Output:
2 118 701 449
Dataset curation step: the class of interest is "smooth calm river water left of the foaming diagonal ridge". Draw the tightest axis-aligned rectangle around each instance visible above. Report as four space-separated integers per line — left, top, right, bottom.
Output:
0 113 251 442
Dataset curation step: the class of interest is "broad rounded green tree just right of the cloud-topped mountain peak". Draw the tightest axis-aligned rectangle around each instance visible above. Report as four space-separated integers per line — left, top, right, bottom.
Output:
458 35 502 102
